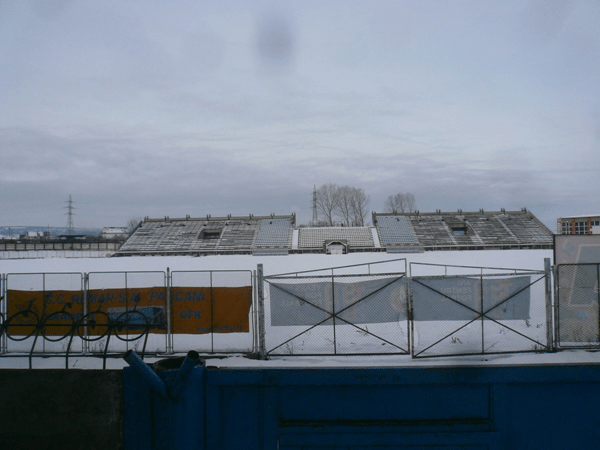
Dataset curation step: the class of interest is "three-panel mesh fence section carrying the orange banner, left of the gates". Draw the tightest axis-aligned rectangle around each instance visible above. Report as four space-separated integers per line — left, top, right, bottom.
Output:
0 270 256 367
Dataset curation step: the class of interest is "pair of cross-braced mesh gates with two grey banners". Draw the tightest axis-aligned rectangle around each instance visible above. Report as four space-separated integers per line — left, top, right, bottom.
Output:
261 260 553 358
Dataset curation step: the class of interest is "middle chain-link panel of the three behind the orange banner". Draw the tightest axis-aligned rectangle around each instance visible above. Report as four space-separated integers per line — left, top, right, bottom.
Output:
85 271 168 354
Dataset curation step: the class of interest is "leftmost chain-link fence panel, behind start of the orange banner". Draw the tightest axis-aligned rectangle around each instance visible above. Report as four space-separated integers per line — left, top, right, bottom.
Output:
2 273 84 354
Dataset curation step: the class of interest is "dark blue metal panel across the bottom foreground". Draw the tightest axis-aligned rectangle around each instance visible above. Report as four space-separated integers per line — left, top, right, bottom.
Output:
125 365 600 450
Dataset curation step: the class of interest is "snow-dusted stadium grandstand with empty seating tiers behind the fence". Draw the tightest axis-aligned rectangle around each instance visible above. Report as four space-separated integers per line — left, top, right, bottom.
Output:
116 208 553 256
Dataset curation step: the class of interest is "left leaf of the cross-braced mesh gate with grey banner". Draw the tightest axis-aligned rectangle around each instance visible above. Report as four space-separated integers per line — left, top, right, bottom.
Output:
265 274 409 355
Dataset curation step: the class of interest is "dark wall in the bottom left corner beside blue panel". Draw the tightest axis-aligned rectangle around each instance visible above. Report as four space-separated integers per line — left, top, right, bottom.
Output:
0 369 123 450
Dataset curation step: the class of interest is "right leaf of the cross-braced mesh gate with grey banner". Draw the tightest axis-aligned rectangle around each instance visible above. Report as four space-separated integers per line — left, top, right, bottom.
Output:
410 272 550 357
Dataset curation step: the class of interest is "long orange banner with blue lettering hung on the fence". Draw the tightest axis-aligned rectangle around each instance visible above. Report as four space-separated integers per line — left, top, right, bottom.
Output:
7 286 252 336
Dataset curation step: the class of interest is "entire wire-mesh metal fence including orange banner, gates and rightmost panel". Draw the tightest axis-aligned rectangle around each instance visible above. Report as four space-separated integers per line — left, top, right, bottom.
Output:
0 259 568 364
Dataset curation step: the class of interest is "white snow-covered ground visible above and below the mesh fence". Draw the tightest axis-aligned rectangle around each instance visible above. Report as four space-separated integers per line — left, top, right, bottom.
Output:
0 250 600 368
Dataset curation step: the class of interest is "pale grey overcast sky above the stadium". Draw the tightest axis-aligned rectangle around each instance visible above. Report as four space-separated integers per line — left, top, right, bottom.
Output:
0 0 600 231
